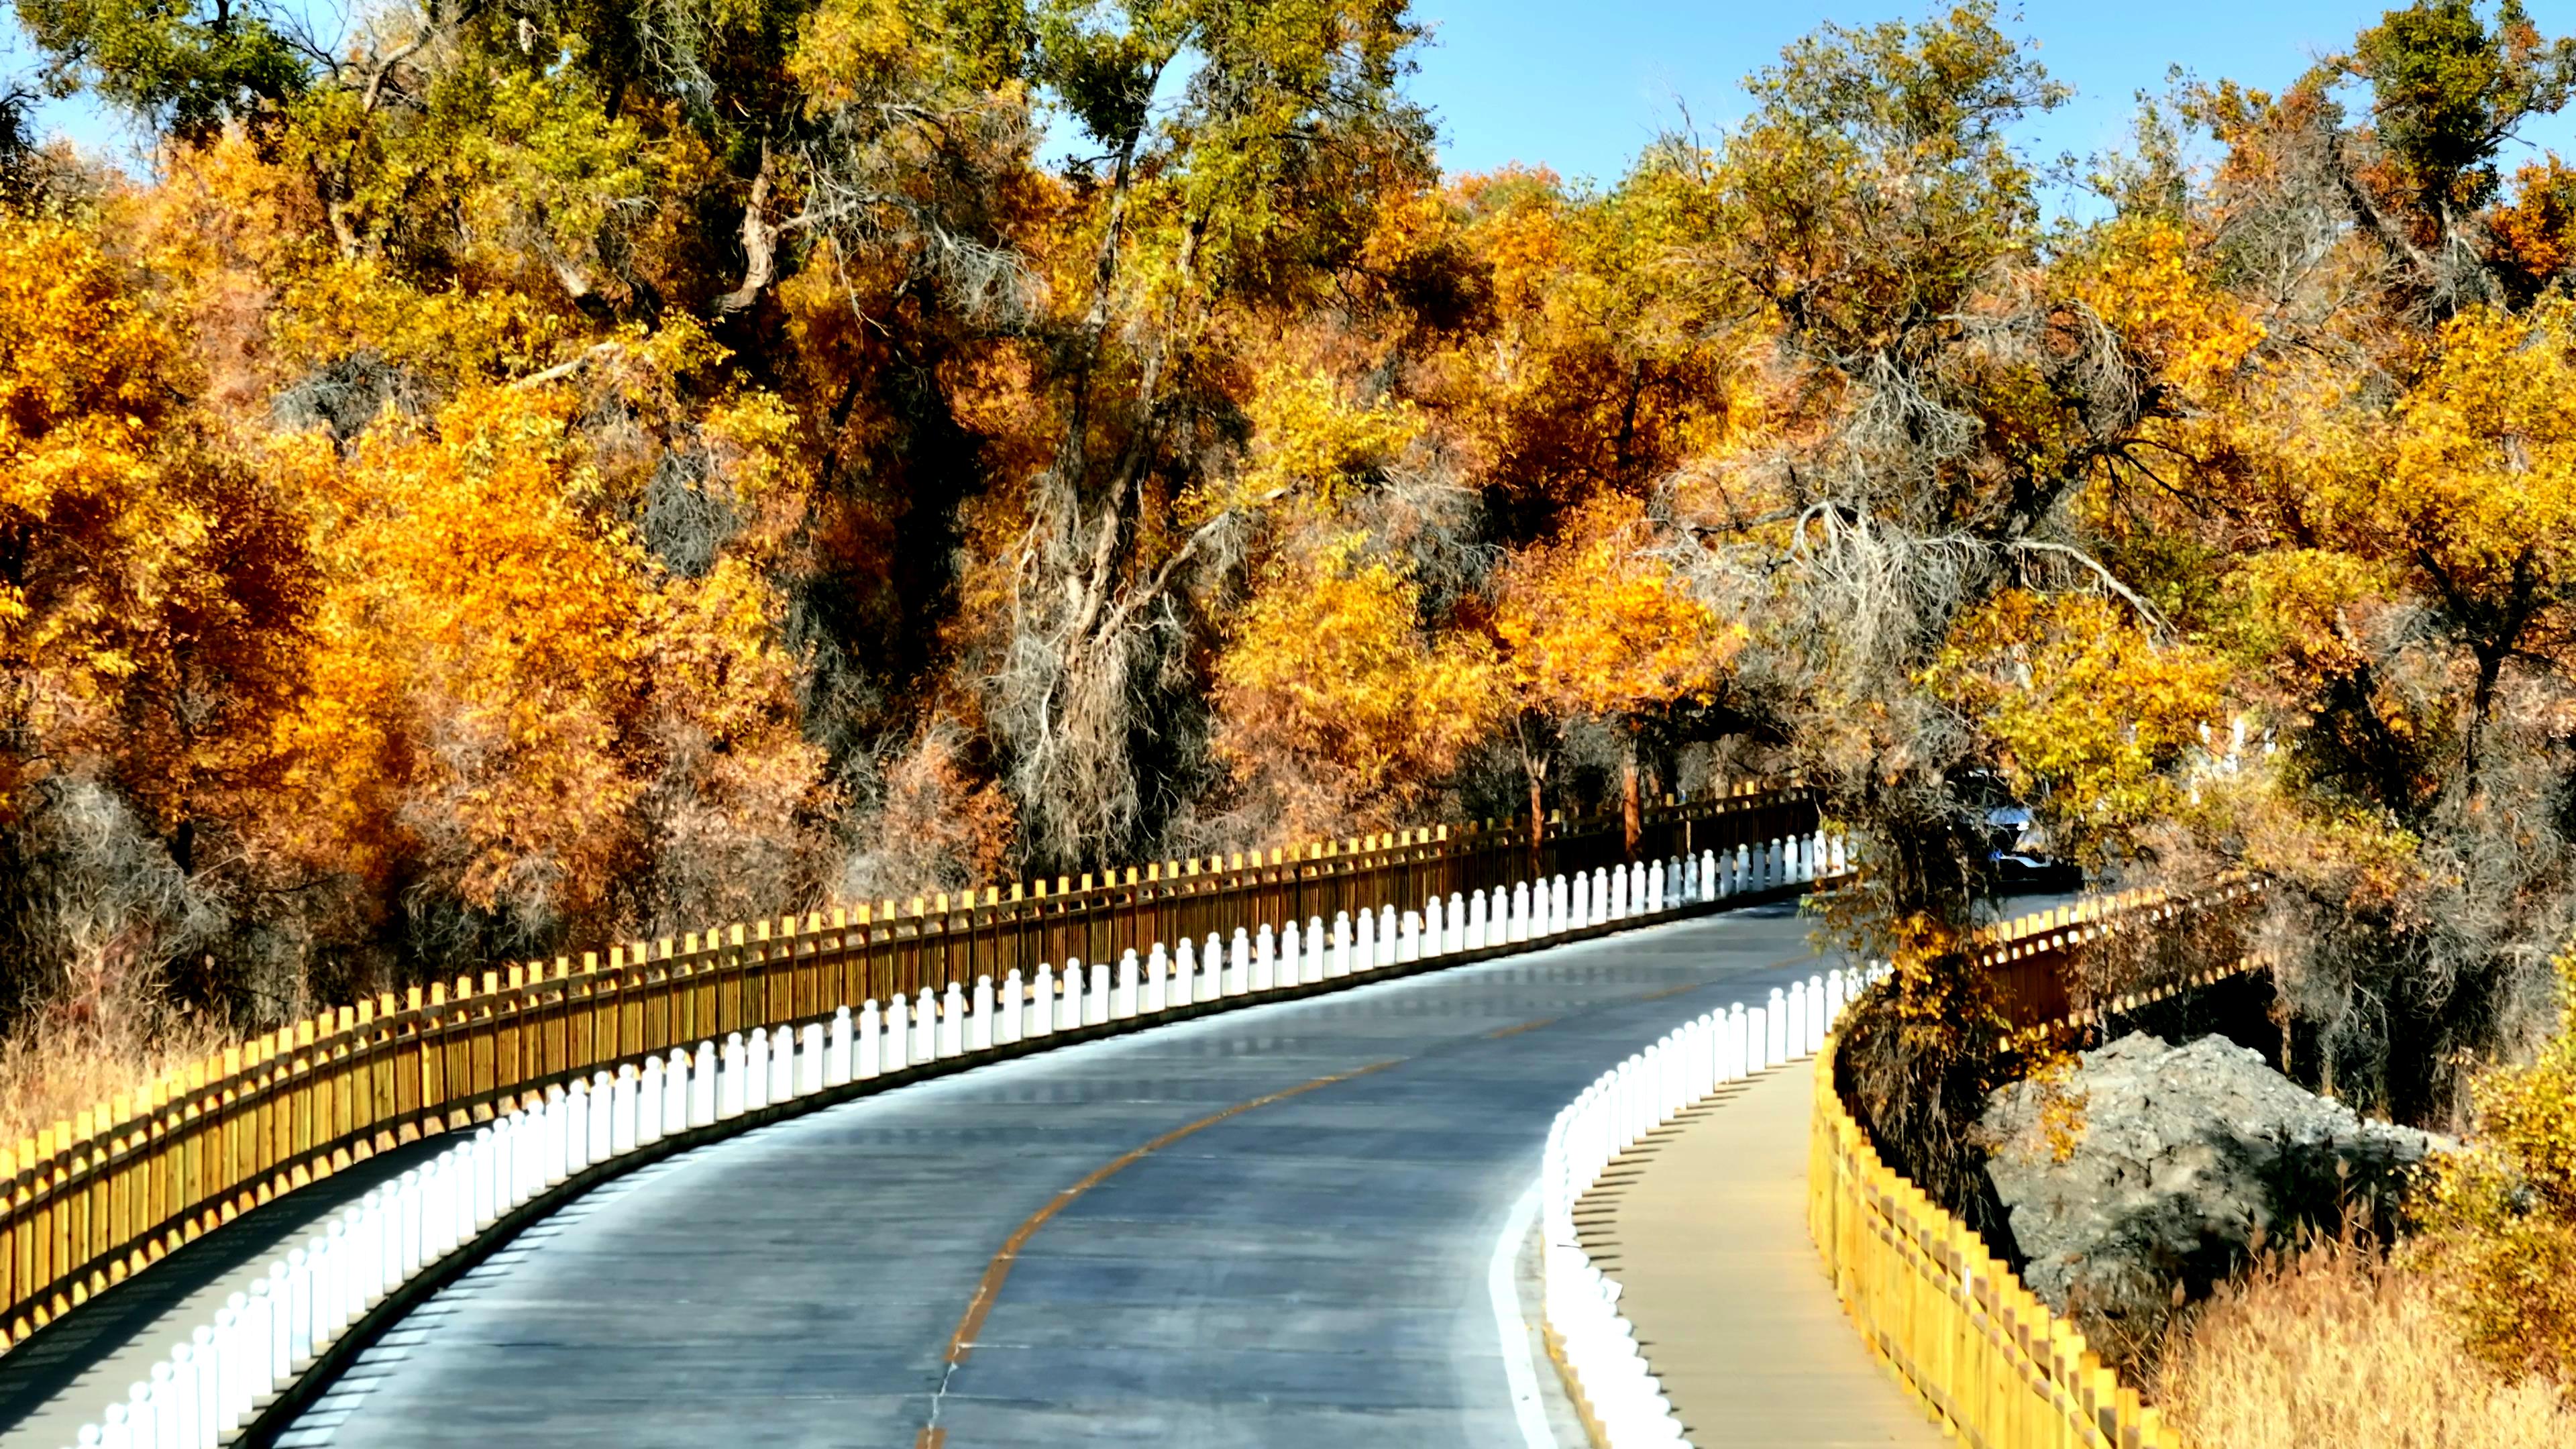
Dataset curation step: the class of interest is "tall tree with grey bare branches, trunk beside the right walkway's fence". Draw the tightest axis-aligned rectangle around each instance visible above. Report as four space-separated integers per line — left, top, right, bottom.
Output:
1669 5 2225 1199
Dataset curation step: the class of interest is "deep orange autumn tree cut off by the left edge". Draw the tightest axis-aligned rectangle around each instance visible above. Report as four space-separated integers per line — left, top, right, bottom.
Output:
0 211 314 1029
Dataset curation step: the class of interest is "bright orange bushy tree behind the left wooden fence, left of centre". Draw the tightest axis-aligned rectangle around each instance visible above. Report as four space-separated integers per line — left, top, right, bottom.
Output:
262 333 824 975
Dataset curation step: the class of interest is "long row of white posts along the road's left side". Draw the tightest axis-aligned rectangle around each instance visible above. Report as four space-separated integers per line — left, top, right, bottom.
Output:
80 833 1842 1449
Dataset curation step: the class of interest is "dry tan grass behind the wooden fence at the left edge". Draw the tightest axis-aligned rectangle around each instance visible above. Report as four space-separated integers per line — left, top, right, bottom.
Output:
0 987 234 1147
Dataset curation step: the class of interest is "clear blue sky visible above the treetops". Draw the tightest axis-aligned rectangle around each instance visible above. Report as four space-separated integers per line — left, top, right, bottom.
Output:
5 0 2576 180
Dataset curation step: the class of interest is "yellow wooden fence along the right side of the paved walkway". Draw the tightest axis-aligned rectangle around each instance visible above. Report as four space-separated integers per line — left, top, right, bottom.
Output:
1806 884 2259 1449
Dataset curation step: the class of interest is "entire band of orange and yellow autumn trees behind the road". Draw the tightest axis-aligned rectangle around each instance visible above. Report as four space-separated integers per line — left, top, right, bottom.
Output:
15 0 2576 1196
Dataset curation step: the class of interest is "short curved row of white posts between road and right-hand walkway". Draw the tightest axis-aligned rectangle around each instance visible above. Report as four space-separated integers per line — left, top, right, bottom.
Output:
1538 964 1886 1449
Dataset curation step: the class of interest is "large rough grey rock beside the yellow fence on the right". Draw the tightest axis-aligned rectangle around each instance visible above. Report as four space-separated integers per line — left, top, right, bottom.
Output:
1978 1034 2439 1364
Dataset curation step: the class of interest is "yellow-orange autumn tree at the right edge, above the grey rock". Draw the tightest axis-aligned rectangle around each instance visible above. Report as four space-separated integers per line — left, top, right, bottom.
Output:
2086 3 2571 1124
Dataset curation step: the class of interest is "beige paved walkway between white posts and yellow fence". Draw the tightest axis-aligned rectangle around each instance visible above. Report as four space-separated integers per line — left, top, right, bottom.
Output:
1576 1062 1945 1449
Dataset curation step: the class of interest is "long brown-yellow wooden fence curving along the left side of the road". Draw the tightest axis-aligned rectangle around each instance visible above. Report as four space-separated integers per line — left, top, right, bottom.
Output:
0 786 1816 1346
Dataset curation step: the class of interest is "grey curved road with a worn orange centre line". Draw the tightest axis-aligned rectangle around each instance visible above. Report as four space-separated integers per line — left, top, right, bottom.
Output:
283 908 1824 1449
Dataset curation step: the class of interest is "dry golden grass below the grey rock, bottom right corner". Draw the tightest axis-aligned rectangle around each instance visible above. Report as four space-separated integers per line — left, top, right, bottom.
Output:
2156 1227 2576 1449
